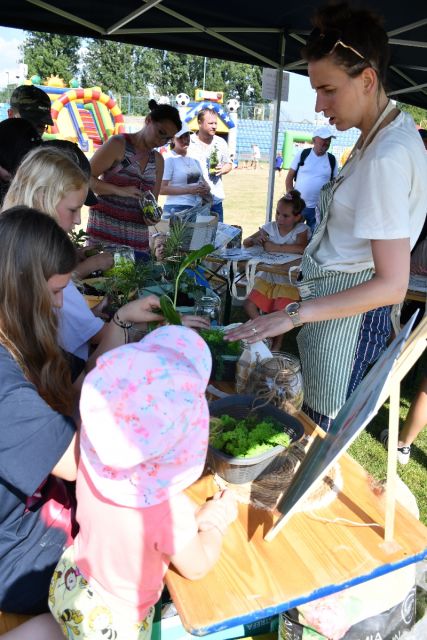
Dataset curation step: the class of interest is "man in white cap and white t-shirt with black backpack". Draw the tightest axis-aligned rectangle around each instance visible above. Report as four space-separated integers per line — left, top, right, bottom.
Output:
286 126 338 231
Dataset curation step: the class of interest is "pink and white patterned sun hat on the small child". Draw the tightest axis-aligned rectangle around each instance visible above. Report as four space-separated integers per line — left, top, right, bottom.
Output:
80 326 212 507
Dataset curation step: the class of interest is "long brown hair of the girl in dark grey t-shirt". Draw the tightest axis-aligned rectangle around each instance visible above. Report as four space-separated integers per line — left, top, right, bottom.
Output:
0 206 76 415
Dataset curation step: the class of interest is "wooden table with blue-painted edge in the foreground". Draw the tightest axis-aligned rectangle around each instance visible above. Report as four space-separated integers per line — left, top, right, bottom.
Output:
166 414 427 635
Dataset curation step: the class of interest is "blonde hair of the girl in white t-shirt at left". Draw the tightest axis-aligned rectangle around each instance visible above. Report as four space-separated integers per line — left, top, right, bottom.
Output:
3 147 89 220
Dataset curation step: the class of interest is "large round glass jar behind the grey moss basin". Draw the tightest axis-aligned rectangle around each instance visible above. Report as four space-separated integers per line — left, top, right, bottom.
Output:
245 352 304 414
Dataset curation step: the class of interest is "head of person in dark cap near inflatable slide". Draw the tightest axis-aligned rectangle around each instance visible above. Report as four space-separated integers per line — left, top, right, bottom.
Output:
8 84 53 135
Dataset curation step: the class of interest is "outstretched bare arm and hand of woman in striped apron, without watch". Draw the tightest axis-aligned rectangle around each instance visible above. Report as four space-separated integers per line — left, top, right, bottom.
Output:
226 238 410 342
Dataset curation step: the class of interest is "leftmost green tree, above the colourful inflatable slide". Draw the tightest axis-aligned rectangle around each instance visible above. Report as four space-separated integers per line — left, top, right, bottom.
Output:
21 31 81 84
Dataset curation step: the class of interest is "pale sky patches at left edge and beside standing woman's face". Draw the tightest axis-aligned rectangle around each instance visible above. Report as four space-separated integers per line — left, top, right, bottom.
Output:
0 27 315 121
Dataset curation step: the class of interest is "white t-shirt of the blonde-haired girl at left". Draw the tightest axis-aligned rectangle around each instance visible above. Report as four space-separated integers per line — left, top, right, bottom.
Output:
58 281 104 360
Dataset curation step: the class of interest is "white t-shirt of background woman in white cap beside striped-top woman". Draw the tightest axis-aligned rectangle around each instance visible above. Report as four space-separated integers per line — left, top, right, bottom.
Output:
163 151 203 207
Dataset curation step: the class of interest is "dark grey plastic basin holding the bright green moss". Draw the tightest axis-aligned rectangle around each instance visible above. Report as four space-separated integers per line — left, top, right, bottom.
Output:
207 395 304 484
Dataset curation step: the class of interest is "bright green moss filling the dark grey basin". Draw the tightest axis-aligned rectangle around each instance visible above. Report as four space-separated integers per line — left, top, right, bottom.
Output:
210 415 291 458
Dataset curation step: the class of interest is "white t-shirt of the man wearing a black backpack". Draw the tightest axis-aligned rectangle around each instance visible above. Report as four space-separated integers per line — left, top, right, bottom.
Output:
291 149 338 208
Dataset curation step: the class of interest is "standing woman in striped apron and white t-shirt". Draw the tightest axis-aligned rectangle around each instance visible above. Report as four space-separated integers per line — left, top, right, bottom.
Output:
228 4 427 430
